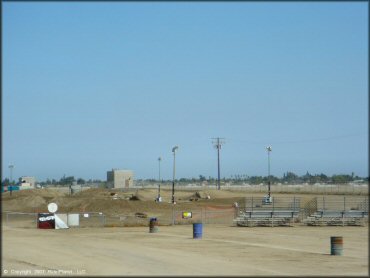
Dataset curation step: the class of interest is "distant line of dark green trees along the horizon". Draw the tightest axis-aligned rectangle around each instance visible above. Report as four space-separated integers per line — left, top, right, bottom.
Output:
2 172 369 186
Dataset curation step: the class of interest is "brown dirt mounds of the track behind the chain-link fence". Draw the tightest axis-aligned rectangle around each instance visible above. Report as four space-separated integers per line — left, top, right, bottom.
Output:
2 188 367 215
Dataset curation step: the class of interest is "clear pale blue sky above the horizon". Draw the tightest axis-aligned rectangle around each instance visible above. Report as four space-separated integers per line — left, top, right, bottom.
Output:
1 2 369 181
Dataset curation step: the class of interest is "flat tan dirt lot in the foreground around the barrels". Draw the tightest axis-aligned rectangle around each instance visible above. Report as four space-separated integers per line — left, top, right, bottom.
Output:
2 225 368 276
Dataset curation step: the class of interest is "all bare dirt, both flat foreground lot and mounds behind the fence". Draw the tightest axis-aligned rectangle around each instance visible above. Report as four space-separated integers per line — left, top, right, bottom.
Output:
1 189 369 277
